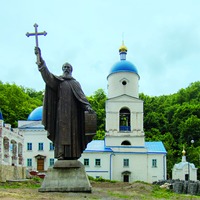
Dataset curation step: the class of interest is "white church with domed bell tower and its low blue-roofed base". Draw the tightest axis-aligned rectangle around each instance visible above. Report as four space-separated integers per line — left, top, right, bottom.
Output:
80 44 167 183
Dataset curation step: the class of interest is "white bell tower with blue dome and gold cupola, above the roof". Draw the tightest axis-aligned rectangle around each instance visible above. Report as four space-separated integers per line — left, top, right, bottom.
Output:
105 42 145 148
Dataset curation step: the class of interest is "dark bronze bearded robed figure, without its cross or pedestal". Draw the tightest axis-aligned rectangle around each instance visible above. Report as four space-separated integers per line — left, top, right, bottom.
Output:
35 47 94 160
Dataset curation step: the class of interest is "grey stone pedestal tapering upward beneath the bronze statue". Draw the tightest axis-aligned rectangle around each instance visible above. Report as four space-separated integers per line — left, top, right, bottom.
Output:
38 160 92 192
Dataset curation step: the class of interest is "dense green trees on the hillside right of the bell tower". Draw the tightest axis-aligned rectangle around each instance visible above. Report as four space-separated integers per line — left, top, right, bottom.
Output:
140 82 200 178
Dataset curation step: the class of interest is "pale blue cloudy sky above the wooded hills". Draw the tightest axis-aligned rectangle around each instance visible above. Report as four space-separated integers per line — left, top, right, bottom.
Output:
0 0 200 96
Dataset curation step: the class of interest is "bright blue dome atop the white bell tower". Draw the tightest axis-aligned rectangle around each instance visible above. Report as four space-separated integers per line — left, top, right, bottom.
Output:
109 60 138 75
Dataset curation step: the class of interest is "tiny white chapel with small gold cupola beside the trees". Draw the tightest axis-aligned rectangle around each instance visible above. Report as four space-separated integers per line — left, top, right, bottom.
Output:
172 149 197 181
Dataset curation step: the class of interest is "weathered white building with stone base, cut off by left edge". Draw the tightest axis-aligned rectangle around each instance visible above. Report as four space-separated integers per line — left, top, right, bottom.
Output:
0 111 26 182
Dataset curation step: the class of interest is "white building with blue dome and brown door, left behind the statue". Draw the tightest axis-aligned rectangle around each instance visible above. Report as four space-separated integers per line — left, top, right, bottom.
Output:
18 106 55 172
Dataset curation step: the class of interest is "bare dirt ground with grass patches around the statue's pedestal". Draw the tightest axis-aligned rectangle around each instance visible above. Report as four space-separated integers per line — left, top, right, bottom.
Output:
0 182 199 200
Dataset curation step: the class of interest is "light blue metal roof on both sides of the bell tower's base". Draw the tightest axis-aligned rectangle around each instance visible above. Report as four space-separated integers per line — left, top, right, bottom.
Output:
84 140 167 154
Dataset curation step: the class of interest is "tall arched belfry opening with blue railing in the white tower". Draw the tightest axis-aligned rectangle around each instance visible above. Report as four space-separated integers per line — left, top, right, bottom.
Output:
119 108 131 132
